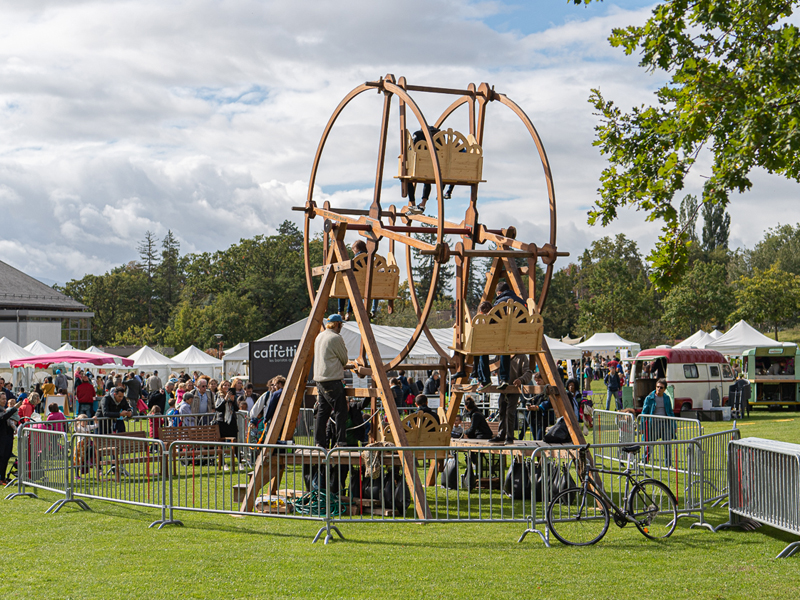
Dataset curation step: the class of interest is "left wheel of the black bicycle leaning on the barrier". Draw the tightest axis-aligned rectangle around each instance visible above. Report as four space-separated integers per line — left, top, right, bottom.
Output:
547 488 608 546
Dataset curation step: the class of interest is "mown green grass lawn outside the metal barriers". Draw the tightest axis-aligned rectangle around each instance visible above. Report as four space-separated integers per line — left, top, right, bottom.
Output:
6 392 800 599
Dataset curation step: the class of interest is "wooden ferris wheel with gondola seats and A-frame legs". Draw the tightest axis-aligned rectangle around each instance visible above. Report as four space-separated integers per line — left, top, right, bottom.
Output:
245 75 583 516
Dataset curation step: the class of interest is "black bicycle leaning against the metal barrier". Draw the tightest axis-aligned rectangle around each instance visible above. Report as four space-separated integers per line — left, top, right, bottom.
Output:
547 444 678 546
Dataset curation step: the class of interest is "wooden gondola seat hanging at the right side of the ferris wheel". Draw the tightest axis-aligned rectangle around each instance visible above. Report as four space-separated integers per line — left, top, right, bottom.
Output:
451 298 544 356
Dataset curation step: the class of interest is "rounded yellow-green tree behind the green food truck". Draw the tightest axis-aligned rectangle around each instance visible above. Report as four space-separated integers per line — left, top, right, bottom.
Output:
731 265 800 340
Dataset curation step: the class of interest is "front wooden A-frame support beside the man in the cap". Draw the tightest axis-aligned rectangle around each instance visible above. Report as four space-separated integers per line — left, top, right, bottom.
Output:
241 223 431 519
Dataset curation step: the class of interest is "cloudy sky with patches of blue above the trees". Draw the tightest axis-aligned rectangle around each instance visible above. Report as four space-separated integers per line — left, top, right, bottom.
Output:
0 0 798 283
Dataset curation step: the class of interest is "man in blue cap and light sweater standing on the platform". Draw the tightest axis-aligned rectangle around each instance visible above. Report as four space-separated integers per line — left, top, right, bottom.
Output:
314 314 348 448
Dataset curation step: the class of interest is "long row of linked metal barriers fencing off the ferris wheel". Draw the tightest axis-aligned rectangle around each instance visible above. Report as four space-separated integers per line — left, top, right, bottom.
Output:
9 427 744 545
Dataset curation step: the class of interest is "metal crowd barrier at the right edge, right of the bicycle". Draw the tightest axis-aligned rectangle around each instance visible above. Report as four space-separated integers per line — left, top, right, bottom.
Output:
717 438 800 558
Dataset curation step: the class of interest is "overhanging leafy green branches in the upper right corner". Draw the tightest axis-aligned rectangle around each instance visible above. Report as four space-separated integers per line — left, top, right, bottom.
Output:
584 0 800 289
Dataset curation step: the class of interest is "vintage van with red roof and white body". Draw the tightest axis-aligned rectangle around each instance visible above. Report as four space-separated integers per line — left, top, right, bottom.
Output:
629 348 734 416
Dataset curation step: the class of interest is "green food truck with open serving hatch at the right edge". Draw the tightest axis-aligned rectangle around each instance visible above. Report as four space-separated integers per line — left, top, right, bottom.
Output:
742 346 800 410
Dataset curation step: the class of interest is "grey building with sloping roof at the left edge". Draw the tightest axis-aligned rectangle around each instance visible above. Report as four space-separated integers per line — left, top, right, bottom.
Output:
0 261 94 349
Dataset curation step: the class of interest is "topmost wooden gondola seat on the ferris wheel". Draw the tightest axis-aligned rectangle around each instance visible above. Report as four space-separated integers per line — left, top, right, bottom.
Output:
398 129 483 184
